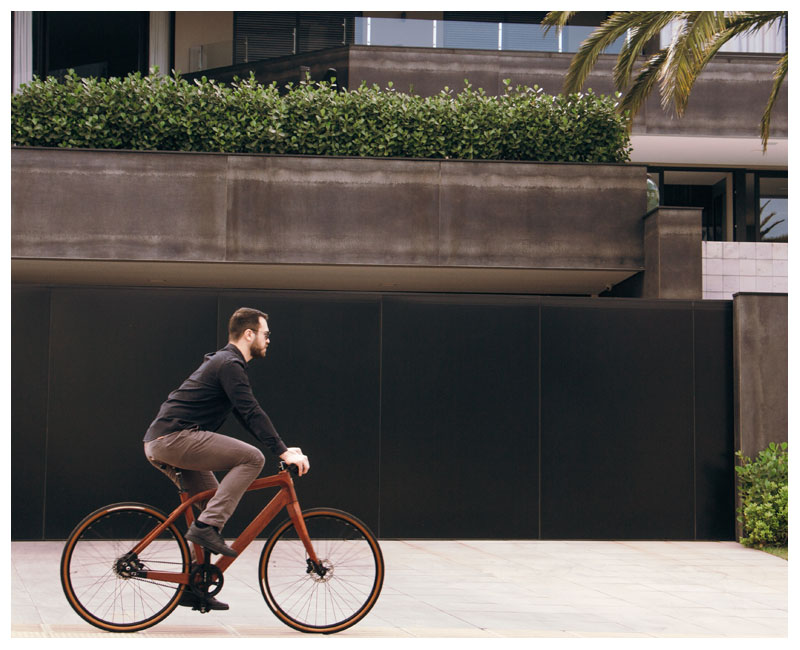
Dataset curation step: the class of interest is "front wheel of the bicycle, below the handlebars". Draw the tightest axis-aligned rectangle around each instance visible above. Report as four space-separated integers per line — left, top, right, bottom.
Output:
259 508 384 634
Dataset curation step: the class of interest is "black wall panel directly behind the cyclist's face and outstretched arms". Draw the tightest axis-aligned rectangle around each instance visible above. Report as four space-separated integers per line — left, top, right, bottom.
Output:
219 291 380 532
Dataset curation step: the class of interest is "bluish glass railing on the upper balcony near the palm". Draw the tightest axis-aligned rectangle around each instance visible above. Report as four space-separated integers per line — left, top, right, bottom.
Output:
355 17 624 54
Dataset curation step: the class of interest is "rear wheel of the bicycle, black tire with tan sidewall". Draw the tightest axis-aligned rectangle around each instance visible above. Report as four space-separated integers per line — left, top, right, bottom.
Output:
60 502 191 632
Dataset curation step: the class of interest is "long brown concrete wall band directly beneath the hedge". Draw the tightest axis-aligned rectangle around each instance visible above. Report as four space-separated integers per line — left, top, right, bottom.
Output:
11 149 646 274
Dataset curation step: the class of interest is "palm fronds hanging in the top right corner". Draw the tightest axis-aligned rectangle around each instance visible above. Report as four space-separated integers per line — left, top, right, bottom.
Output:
542 11 789 150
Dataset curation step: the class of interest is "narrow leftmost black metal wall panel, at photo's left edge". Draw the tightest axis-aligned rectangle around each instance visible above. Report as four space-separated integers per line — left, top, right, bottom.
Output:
11 288 50 539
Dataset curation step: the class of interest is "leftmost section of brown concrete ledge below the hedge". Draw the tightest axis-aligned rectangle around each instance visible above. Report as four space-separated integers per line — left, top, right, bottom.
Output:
11 149 227 260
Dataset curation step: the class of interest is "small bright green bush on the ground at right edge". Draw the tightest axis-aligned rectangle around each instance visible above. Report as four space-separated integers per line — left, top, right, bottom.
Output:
736 442 789 548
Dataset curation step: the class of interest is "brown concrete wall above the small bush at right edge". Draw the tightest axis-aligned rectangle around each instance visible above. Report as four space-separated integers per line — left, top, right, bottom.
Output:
733 293 789 458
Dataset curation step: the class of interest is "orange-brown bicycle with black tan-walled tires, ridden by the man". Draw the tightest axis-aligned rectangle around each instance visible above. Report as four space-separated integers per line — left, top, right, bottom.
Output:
60 462 384 634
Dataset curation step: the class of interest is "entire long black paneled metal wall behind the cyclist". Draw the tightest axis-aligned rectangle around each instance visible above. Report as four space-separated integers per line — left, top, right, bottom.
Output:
12 287 734 539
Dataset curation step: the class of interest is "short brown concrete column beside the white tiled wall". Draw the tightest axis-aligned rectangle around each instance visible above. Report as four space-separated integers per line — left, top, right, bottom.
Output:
642 206 703 300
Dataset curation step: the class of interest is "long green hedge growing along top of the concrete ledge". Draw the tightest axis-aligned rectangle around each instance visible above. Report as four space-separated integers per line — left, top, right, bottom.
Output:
11 71 630 162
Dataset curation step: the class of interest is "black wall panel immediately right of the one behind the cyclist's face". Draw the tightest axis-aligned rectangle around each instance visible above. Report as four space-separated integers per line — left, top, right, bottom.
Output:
380 296 539 538
